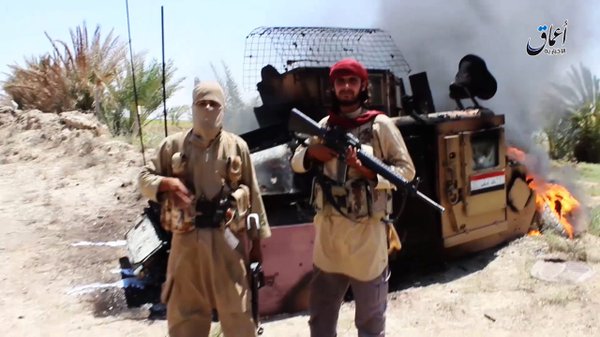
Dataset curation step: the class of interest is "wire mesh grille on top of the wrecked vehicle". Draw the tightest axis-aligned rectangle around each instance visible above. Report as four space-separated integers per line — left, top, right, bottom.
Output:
243 27 410 90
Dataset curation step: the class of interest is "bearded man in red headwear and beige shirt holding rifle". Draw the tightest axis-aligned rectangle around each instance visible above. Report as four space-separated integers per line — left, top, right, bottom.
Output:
291 59 415 337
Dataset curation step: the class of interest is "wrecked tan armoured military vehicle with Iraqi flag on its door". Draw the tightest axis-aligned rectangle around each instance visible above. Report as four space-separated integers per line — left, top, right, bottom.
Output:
122 27 536 316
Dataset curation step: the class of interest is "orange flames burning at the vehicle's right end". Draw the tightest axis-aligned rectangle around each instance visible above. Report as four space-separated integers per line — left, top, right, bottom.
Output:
507 147 580 239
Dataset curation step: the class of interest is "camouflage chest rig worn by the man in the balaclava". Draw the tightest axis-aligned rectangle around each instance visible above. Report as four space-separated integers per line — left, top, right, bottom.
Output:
161 131 250 233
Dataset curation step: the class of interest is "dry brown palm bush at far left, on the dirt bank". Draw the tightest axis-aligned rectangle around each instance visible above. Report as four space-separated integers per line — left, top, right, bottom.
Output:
3 23 126 112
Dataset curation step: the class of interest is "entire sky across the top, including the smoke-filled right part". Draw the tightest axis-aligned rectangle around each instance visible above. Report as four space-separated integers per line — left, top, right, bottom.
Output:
0 0 600 115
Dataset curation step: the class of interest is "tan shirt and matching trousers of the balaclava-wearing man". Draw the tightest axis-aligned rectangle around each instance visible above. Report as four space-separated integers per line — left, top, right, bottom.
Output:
139 131 271 336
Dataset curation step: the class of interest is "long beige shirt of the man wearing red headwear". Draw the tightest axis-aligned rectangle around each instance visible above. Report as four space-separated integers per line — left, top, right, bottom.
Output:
291 111 415 281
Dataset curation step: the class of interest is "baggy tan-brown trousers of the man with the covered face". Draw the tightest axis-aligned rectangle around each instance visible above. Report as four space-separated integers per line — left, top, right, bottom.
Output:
161 229 256 337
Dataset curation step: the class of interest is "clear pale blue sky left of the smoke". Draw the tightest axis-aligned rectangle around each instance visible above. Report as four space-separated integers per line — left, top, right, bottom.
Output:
0 0 378 104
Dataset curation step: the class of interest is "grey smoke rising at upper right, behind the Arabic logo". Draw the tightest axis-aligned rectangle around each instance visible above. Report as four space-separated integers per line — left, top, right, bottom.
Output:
378 0 600 150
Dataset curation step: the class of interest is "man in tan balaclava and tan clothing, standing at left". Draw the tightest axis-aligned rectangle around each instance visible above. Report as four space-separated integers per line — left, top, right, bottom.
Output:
139 82 271 337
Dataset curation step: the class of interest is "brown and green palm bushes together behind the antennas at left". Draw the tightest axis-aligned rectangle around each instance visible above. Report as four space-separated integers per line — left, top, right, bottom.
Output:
3 22 183 135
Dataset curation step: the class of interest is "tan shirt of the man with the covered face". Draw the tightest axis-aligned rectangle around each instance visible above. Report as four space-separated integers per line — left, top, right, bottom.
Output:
139 131 271 238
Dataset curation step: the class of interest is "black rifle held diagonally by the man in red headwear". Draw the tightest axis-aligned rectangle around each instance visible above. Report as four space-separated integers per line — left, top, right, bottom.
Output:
288 108 445 213
